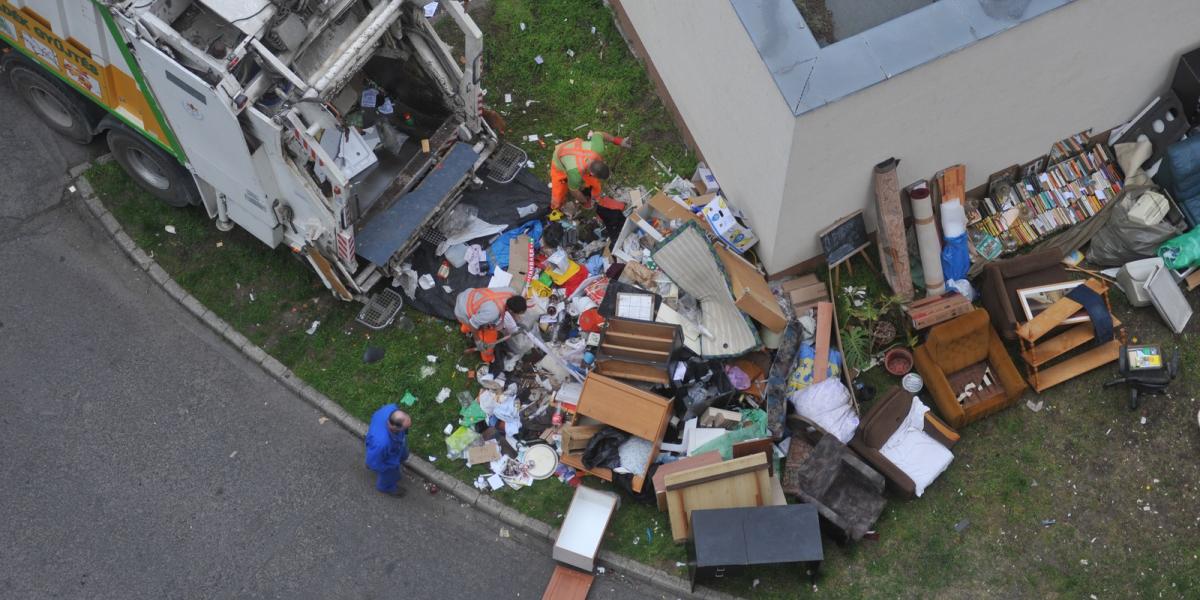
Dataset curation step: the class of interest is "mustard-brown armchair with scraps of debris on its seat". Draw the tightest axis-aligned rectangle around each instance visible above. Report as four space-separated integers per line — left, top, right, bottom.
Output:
916 308 1028 428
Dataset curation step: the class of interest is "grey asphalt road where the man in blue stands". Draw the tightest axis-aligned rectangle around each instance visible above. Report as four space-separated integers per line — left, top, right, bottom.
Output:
0 70 661 600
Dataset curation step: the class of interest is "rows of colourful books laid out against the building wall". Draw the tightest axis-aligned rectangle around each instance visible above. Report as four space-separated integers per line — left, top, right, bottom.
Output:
972 136 1122 246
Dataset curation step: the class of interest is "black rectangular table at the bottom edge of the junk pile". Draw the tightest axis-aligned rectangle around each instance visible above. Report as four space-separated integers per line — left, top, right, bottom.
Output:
688 504 824 592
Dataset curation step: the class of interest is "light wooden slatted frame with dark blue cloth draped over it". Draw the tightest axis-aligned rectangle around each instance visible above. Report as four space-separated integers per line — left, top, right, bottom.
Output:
1016 278 1124 394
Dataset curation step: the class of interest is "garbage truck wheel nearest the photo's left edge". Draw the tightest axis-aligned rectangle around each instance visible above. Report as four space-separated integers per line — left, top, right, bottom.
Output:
4 56 94 144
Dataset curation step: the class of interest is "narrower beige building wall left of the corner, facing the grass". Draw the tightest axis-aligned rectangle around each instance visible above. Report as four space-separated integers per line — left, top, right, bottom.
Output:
612 0 796 265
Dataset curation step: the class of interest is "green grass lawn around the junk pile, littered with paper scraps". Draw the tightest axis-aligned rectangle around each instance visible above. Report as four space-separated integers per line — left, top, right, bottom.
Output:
88 0 1200 599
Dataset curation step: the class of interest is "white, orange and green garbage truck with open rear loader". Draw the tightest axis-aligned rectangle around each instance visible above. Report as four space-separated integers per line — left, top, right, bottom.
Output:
0 0 524 301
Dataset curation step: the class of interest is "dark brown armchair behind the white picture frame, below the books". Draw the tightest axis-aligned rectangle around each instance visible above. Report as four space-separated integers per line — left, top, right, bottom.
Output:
979 248 1072 341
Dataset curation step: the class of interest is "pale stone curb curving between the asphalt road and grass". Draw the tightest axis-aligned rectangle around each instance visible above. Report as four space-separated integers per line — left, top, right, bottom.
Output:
77 166 737 600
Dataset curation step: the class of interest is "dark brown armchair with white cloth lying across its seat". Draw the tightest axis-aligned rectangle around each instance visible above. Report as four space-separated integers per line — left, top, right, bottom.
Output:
850 388 959 498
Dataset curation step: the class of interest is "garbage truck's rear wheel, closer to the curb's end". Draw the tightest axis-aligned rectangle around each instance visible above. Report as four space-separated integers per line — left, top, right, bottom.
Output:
108 127 199 208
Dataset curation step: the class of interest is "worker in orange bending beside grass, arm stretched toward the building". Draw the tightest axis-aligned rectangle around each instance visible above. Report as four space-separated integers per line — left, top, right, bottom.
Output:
550 131 630 241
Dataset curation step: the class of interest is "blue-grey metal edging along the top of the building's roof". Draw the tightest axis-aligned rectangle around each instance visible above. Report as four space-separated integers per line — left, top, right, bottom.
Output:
730 0 1076 116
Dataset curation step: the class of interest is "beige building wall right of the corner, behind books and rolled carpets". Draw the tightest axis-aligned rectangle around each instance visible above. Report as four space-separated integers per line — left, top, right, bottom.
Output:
772 0 1200 272
